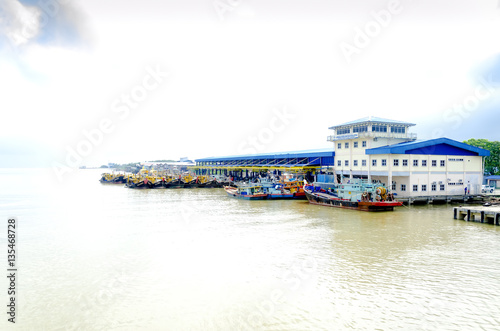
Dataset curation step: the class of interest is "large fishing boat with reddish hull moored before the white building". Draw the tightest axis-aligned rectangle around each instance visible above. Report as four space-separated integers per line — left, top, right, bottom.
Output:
304 180 403 211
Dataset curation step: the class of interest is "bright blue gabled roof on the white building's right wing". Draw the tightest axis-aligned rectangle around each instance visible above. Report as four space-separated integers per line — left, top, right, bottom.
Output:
366 138 490 156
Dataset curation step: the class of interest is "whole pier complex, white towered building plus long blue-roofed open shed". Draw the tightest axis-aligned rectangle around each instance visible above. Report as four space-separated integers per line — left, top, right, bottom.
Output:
192 116 490 202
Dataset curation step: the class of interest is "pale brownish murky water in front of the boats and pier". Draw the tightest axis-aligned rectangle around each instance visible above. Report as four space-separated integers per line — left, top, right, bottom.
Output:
0 169 500 330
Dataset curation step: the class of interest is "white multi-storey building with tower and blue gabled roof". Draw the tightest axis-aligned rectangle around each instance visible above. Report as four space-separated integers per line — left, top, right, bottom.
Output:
327 117 490 198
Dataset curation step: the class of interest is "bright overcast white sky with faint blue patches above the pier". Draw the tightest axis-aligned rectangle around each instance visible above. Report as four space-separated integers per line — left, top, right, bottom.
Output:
0 0 500 173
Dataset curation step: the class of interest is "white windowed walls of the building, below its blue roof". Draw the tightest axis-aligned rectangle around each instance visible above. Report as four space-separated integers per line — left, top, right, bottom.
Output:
334 123 483 197
